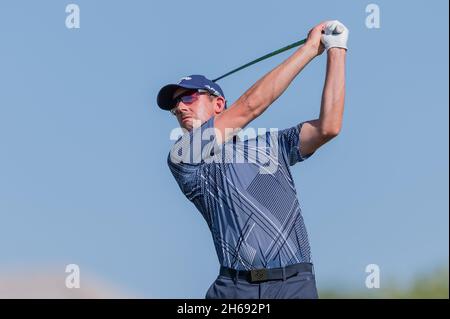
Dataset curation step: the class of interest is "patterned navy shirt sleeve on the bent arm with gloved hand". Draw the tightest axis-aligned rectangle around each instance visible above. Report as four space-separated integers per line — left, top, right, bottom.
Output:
278 122 314 166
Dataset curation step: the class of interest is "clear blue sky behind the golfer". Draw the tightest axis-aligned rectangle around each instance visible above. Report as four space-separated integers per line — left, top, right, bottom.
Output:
0 0 449 298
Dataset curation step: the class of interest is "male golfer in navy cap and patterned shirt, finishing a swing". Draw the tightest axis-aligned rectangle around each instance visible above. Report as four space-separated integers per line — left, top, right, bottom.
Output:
157 21 348 299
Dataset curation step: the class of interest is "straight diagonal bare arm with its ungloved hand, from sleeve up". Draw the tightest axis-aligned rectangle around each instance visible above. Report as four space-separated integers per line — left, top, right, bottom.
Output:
214 23 324 140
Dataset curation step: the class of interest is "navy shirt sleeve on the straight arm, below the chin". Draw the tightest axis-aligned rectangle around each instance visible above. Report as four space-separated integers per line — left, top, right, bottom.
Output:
167 117 216 200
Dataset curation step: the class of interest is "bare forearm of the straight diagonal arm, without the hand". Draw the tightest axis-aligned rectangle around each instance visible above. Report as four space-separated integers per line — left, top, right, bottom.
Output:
240 45 315 118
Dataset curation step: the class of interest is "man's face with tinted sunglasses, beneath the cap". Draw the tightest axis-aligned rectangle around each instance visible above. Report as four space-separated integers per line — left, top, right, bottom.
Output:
172 88 224 131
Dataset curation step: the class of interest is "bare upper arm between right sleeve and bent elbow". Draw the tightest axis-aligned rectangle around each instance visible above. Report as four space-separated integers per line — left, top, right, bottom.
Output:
299 119 332 155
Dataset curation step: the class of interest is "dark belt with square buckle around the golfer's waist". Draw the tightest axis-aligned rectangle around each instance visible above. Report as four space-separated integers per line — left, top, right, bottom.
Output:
220 263 313 282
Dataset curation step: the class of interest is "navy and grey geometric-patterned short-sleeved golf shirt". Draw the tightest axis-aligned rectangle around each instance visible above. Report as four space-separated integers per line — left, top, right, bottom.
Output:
168 117 313 270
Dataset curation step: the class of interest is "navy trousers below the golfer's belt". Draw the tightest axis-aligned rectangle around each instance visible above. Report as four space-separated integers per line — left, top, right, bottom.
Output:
205 264 319 299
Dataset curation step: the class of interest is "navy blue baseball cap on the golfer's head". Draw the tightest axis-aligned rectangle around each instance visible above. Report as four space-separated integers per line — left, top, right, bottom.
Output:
157 74 225 110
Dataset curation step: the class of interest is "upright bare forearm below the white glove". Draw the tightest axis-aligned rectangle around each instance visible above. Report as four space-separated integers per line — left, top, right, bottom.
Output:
319 48 346 136
